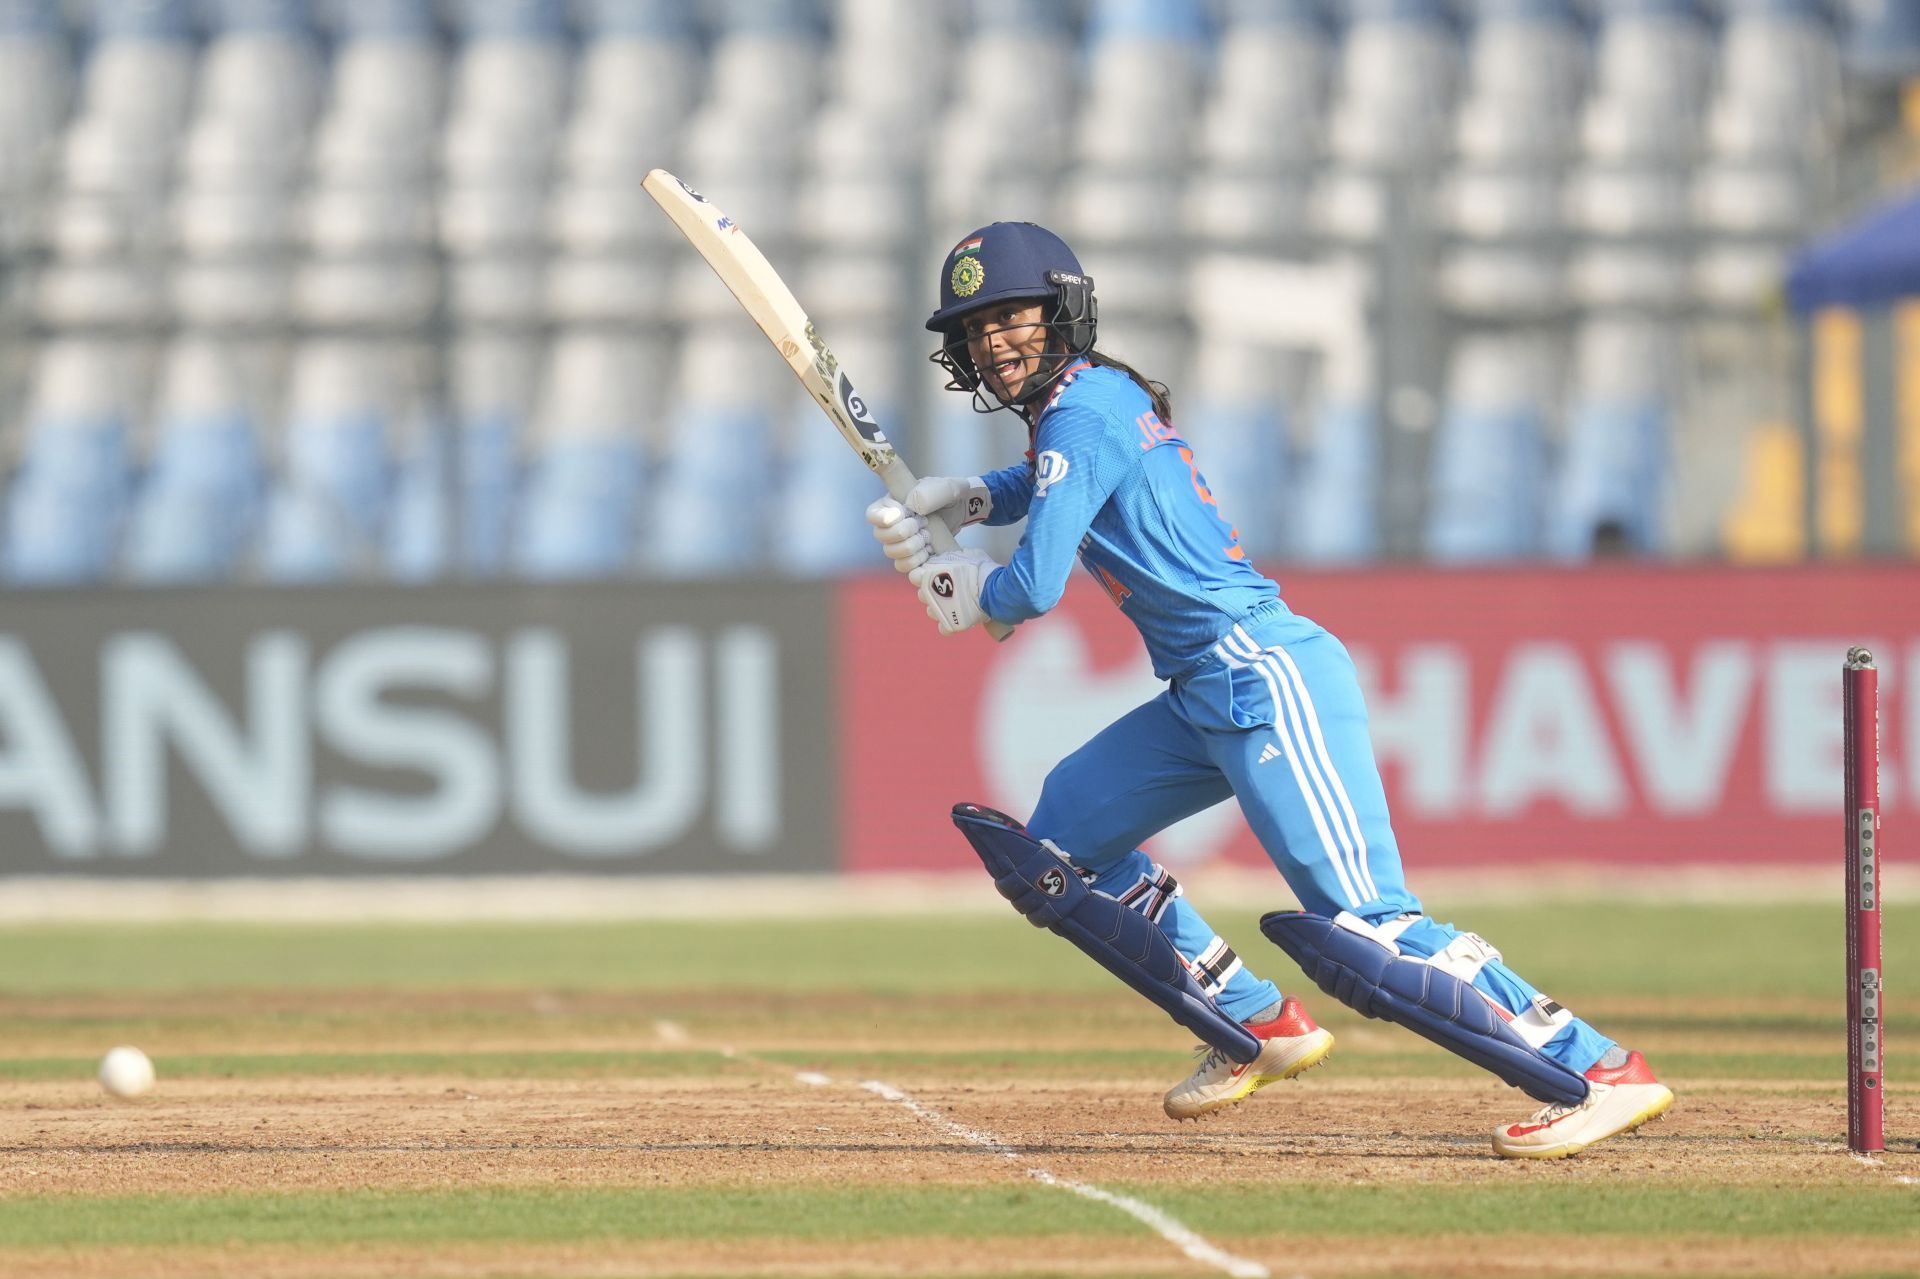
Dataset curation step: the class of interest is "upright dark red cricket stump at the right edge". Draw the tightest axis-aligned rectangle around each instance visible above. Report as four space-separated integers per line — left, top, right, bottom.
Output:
1841 647 1885 1152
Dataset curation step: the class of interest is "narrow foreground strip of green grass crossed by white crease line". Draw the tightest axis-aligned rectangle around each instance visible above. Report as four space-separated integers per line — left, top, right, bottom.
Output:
0 1181 1920 1248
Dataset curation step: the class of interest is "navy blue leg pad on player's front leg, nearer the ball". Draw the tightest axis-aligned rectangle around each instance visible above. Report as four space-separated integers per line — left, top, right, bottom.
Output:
954 805 1260 1062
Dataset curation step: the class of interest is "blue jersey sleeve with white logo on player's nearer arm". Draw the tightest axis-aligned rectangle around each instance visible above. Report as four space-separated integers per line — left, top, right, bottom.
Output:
979 407 1127 622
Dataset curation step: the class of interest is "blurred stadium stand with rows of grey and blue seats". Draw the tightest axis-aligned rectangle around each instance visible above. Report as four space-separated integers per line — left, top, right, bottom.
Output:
0 0 1920 584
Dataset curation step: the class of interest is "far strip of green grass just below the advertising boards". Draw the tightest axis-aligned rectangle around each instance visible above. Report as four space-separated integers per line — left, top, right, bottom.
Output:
0 902 1896 1002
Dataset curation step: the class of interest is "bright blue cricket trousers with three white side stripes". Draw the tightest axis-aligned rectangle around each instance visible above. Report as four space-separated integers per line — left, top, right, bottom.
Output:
1027 603 1613 1070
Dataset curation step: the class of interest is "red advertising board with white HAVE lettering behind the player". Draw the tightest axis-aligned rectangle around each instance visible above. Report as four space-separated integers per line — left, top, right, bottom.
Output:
839 565 1920 870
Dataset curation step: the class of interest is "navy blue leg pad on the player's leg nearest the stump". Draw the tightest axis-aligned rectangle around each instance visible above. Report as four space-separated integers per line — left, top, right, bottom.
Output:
1260 910 1586 1106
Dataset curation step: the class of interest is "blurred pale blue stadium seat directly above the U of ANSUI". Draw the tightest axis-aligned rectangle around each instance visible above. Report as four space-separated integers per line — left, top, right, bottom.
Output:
513 438 641 578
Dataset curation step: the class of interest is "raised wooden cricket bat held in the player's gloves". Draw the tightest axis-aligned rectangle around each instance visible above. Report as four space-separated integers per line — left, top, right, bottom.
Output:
643 169 1014 640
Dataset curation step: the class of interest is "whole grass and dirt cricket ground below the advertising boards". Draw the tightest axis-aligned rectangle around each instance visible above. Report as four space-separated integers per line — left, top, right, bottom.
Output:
0 894 1920 1277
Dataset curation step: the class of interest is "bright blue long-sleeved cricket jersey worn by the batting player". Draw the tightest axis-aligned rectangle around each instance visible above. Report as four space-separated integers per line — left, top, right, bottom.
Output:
979 361 1281 680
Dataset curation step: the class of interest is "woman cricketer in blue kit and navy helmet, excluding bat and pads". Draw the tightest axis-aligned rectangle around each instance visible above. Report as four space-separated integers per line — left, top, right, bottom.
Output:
868 223 1672 1158
